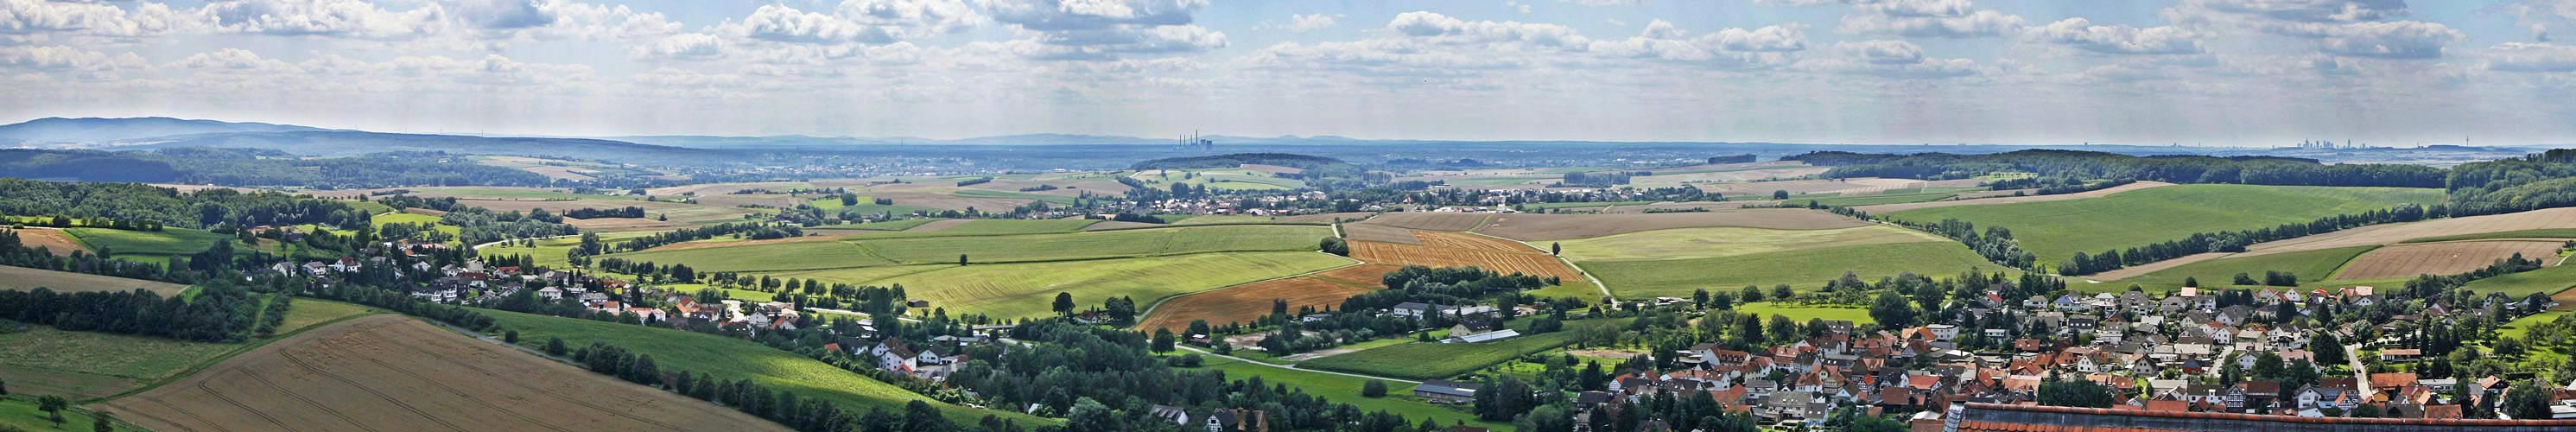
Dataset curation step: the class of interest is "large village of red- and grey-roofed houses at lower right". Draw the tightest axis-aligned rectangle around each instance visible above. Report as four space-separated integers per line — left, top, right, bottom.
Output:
1566 288 2576 424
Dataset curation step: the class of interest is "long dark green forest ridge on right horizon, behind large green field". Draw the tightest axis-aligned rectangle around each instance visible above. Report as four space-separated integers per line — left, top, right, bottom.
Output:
1783 149 2447 187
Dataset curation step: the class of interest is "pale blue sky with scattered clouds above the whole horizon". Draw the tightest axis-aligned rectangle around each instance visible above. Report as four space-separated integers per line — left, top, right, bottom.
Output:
0 0 2576 147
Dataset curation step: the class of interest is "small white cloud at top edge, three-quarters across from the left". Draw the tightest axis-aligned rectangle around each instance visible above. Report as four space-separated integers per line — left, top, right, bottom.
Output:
1842 0 2022 39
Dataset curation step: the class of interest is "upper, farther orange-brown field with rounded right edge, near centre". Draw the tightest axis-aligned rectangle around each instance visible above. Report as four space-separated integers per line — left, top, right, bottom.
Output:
1350 232 1584 280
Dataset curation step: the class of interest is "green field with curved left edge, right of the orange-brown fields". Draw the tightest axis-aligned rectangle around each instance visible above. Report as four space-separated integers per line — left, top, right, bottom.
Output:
1574 242 2002 298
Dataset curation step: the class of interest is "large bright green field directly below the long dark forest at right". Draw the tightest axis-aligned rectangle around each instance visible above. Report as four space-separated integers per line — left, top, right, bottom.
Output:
1886 185 2442 265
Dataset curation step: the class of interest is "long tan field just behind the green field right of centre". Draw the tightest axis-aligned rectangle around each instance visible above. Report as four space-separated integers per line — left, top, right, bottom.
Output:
1476 208 1868 242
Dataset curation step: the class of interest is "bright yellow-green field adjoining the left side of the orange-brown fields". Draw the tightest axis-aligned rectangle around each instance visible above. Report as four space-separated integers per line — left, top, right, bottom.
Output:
778 252 1350 319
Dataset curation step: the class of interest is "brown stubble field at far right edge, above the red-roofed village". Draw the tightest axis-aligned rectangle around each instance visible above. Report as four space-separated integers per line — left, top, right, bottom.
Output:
2334 242 2566 280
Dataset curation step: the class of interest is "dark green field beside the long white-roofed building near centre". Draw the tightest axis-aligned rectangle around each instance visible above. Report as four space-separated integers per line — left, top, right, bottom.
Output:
1298 319 1628 380
